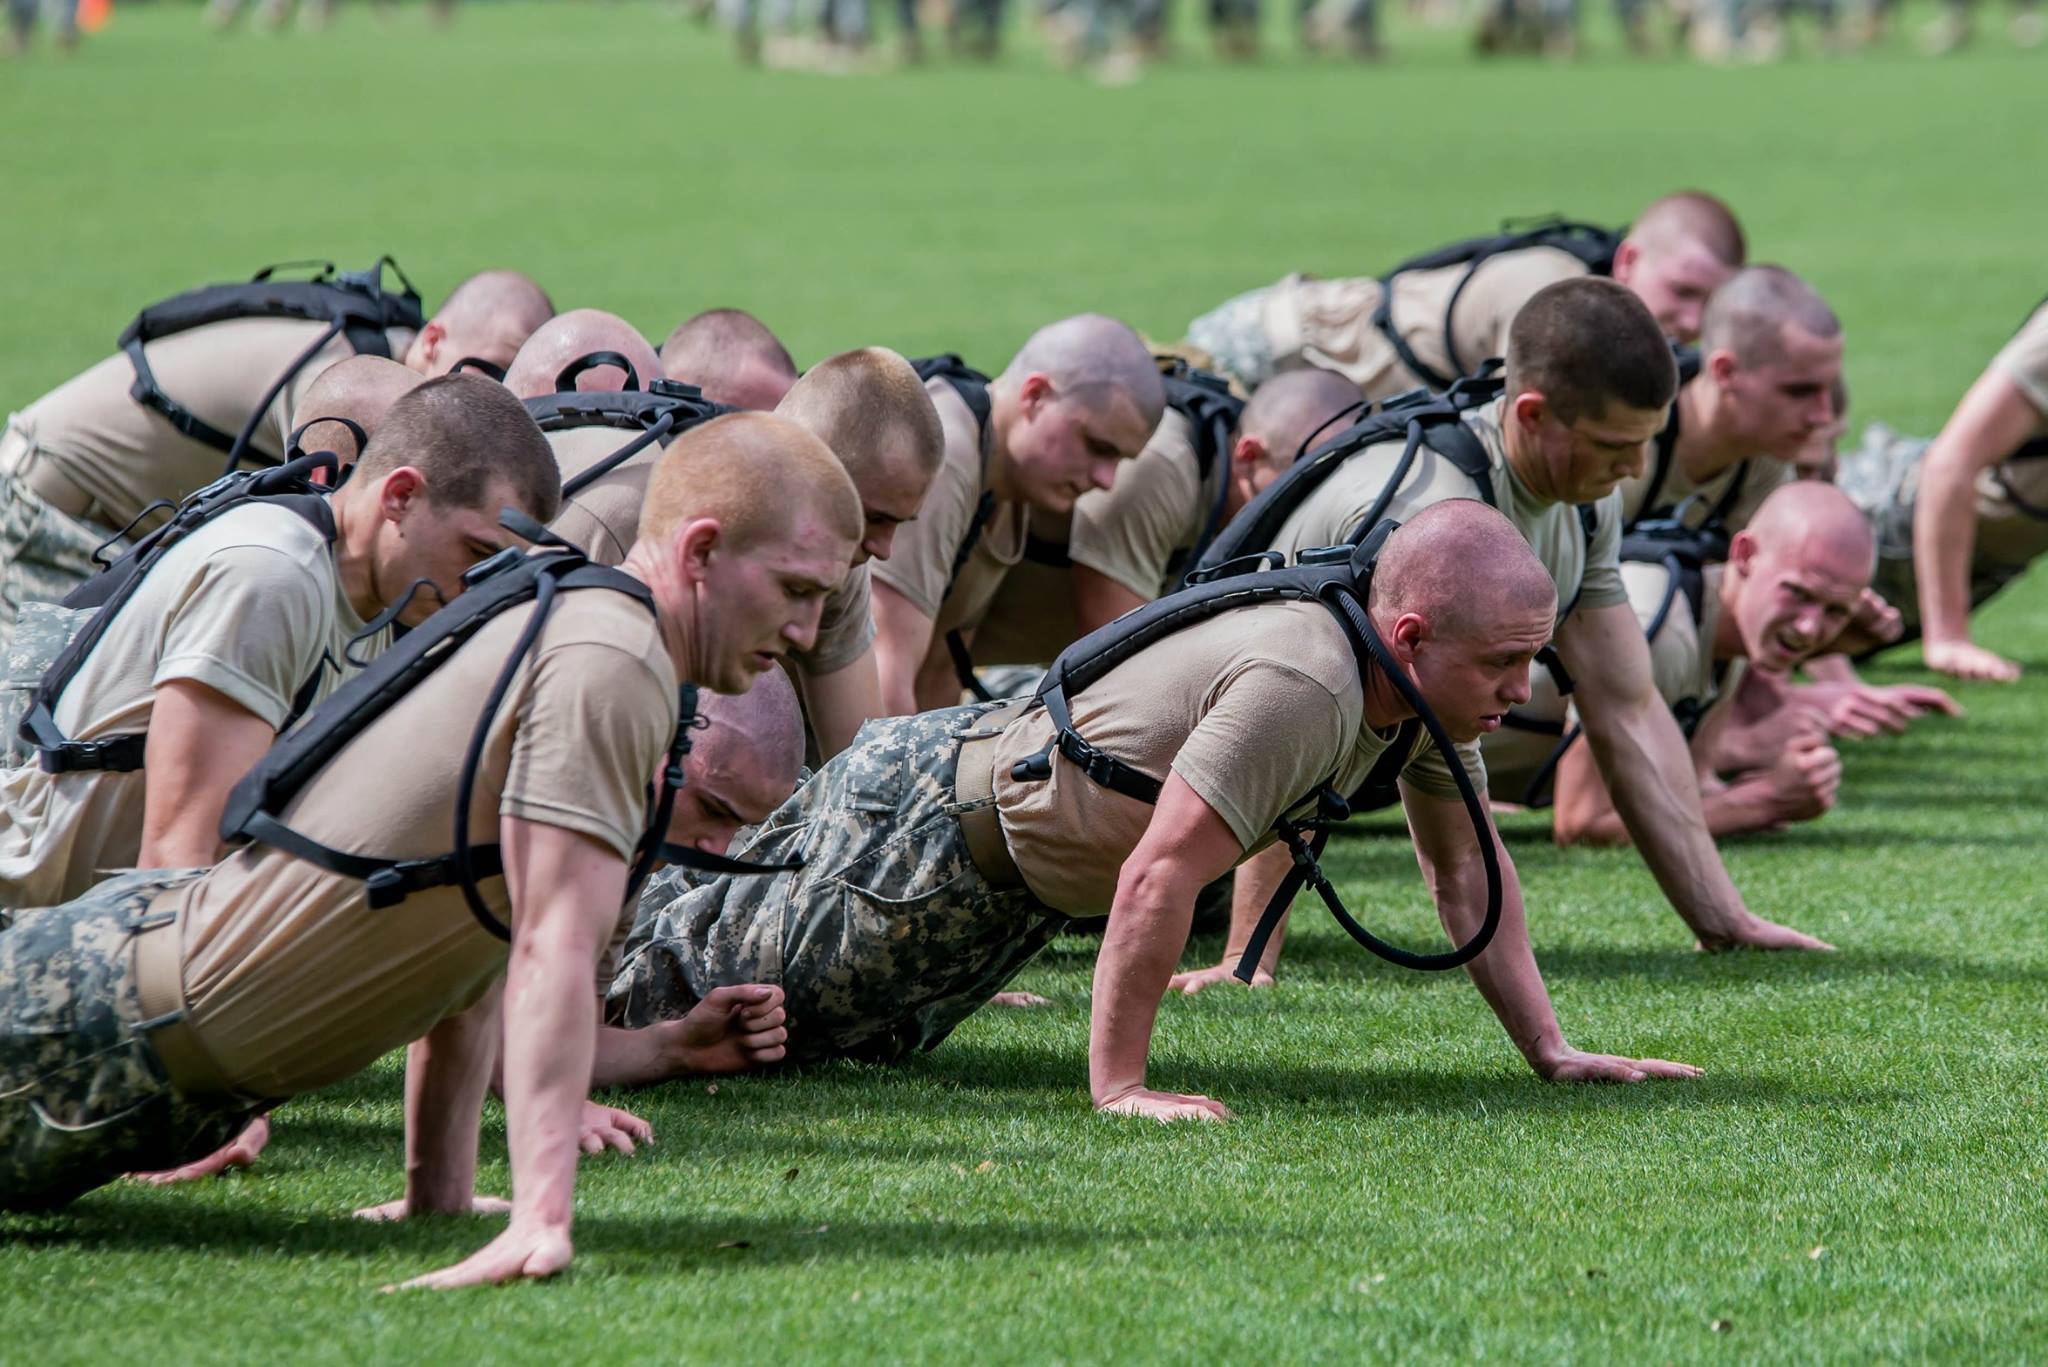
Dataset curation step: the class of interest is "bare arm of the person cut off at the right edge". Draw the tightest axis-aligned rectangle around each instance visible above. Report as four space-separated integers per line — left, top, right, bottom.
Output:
1913 367 2042 682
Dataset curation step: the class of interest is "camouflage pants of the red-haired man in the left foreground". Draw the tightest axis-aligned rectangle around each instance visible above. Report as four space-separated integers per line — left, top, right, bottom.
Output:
0 869 262 1211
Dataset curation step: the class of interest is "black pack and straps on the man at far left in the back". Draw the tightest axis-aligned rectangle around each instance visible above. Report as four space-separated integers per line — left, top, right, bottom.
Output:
117 256 426 471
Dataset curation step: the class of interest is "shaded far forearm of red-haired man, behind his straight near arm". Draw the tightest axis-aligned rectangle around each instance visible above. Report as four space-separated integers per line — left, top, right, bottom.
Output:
406 984 502 1211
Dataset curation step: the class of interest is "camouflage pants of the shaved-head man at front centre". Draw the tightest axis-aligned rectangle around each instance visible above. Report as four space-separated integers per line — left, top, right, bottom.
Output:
606 703 1063 1062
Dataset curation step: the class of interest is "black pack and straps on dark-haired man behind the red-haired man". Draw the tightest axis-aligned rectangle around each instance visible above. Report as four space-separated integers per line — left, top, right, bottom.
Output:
18 453 336 773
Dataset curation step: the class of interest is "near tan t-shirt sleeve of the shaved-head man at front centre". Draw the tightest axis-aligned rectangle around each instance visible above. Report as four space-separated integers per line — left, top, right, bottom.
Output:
1174 660 1352 848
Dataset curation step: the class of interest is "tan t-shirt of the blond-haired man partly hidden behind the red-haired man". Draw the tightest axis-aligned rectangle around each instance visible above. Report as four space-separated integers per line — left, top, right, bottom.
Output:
547 426 874 676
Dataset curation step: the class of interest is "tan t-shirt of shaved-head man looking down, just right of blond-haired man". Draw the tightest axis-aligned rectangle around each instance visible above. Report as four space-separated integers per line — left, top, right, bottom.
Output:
874 379 1030 641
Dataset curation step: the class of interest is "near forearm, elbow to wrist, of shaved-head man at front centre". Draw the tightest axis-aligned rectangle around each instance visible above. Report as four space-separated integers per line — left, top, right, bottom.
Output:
1087 863 1202 1107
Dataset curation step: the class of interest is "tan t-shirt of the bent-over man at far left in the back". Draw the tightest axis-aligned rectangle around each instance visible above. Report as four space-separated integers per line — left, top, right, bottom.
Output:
10 318 410 529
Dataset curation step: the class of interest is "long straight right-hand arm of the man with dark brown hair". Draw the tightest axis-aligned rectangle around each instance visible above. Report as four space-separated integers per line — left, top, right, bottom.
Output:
1556 603 1827 949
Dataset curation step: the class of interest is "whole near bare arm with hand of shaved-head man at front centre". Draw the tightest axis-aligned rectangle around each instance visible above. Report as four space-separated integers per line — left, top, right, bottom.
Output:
1087 773 1243 1121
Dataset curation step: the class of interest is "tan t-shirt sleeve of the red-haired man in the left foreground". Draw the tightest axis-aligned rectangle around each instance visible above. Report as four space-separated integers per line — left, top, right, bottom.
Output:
498 641 676 859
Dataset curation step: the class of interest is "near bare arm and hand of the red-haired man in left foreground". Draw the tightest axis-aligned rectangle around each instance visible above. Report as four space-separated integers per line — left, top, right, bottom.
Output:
391 816 627 1287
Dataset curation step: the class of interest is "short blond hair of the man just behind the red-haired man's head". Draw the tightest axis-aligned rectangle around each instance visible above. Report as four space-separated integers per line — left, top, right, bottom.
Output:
776 346 946 486
